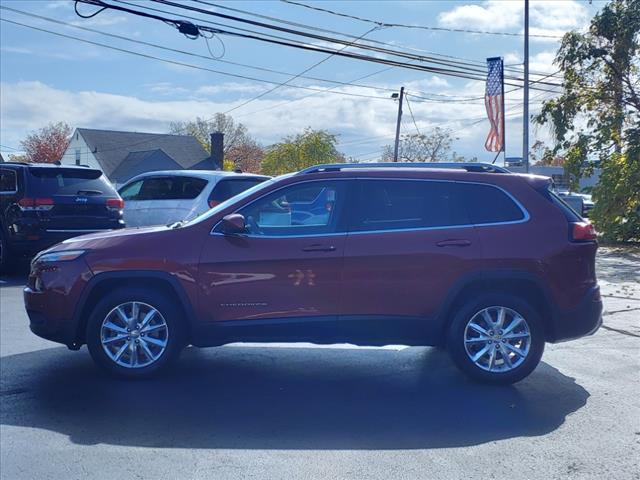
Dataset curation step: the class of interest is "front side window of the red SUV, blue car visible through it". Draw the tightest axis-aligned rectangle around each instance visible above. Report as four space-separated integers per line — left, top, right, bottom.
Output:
238 182 346 236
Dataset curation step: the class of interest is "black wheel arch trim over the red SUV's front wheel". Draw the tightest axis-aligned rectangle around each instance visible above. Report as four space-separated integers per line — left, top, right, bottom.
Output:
74 270 195 348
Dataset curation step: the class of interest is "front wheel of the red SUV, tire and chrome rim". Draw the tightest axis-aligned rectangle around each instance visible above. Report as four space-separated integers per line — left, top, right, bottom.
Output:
87 288 184 377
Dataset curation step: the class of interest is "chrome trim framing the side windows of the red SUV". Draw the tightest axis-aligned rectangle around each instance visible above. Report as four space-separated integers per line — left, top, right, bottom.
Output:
209 177 531 238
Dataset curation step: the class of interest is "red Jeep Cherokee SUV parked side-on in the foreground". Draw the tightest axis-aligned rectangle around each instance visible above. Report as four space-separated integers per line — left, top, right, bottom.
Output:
24 164 602 383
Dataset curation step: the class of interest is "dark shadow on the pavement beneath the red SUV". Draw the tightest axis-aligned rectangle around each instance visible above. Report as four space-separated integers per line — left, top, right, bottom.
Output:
0 346 589 450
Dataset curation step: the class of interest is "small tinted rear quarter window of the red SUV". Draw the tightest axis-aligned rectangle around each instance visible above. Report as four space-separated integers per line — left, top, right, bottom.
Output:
458 183 524 224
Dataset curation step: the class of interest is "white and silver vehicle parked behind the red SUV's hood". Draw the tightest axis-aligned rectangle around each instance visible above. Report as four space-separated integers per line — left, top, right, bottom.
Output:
120 170 269 227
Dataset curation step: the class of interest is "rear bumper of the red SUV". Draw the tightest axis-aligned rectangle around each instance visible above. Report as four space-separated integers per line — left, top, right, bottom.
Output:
548 285 602 343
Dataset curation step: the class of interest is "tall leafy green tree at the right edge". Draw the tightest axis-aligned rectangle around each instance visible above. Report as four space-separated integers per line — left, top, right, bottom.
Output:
535 0 640 241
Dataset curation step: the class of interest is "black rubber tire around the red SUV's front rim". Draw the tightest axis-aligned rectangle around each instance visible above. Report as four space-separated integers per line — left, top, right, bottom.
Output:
86 287 185 378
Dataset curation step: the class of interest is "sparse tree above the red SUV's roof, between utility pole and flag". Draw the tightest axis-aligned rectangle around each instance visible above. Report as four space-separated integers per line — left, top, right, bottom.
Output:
382 127 459 162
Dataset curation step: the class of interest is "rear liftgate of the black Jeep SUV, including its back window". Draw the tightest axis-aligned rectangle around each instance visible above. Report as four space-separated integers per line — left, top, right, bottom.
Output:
25 167 121 232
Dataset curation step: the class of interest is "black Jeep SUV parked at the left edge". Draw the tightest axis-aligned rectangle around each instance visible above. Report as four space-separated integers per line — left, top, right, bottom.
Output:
0 162 124 271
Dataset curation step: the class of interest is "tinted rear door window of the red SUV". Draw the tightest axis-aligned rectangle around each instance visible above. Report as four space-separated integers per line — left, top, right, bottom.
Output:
354 180 469 231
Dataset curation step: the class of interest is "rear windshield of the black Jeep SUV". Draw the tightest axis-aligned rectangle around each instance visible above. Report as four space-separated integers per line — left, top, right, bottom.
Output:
29 168 117 197
